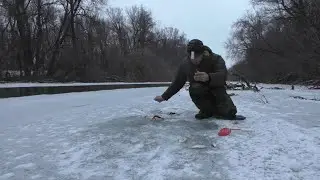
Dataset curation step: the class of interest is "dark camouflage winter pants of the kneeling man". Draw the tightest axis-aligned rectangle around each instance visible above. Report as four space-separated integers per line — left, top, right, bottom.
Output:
189 83 237 117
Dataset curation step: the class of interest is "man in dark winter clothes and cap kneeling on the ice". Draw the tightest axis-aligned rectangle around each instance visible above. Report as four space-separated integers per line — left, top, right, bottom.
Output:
154 39 237 119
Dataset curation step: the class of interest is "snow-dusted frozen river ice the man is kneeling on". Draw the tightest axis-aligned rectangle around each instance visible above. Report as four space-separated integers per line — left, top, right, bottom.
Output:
0 86 320 180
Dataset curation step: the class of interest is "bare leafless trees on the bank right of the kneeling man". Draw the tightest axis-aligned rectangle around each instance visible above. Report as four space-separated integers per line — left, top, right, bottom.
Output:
226 0 320 83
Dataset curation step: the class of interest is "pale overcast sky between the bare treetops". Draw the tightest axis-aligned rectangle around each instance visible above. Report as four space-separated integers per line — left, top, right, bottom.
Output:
109 0 251 67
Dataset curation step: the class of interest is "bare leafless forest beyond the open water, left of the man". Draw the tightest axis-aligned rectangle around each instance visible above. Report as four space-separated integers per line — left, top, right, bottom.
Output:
0 0 187 82
